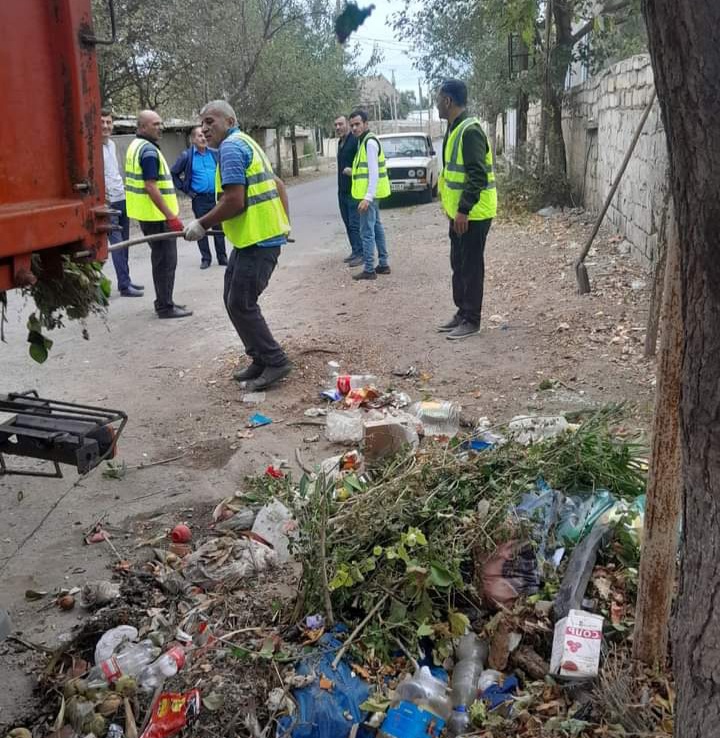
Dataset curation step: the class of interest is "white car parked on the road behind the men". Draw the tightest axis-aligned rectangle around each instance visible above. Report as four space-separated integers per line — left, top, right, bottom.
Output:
378 133 438 202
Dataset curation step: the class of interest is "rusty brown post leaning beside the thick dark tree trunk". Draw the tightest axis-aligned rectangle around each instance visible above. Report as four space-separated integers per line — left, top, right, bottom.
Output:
633 214 683 668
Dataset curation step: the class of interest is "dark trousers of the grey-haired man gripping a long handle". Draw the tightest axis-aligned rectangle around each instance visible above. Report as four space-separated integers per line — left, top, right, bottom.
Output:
223 246 288 366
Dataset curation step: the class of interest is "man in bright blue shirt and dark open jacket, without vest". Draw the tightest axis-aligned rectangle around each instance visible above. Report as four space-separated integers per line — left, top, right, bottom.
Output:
170 126 227 269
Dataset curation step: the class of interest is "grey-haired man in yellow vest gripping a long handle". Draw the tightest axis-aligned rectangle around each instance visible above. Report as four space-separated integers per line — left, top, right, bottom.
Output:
185 100 292 391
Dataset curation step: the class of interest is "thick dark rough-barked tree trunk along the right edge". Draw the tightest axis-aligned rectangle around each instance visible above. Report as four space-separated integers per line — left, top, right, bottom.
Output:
642 0 720 738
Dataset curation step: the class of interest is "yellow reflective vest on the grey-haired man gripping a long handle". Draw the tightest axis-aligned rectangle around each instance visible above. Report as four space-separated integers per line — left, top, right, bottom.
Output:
215 131 290 249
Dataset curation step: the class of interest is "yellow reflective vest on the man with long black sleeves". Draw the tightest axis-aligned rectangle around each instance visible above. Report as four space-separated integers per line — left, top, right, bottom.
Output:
439 118 497 220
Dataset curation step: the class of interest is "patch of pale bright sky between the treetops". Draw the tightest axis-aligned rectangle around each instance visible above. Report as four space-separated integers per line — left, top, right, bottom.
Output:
350 0 425 94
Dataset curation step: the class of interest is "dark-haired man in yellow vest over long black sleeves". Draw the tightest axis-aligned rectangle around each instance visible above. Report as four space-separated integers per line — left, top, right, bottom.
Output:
436 79 497 341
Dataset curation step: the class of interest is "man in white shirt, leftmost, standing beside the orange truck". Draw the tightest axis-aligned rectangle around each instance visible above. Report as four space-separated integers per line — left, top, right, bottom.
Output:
100 108 144 297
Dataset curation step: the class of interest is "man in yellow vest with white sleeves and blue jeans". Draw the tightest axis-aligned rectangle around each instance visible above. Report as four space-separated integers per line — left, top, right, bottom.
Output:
350 110 390 279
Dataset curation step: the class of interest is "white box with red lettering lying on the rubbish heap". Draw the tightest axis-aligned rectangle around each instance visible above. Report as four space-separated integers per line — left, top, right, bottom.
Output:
550 610 603 679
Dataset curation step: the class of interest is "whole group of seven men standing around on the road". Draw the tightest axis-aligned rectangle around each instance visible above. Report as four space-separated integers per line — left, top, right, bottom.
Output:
101 80 497 390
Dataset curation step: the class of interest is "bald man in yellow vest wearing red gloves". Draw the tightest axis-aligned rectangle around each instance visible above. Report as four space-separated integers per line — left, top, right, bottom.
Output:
125 110 192 319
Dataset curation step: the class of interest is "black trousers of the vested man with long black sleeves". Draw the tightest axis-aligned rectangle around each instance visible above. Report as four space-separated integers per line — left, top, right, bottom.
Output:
450 219 492 326
